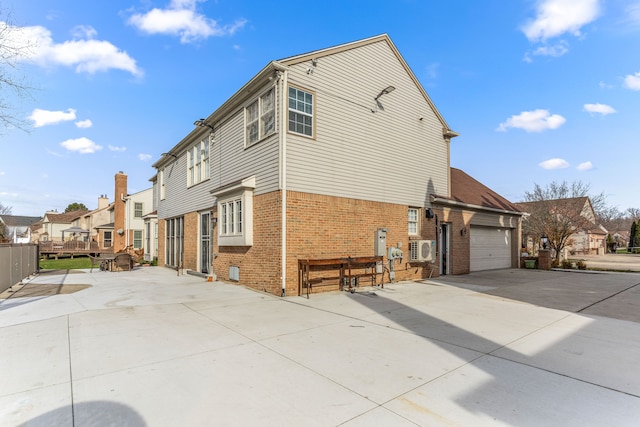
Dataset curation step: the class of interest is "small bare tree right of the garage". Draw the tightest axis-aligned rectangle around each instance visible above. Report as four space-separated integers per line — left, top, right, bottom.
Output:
522 181 606 260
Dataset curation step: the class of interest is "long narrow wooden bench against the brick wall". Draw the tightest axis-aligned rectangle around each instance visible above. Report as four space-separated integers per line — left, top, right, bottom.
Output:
298 256 384 298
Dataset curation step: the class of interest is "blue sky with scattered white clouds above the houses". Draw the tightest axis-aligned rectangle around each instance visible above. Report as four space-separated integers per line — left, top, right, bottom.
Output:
0 0 640 216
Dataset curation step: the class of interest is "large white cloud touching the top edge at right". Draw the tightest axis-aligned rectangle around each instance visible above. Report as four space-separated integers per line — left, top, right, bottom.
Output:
522 0 600 41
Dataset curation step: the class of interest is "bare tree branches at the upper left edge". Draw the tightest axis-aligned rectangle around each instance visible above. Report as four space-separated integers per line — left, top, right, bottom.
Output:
0 10 34 130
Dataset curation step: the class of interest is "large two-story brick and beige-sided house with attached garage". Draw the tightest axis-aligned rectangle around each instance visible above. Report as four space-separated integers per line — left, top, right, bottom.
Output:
151 35 520 295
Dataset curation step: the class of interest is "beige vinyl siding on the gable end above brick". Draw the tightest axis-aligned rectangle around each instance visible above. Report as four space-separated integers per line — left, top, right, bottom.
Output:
287 37 449 206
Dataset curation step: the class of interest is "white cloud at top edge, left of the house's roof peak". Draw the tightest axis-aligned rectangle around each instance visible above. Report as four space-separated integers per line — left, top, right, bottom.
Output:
129 0 247 43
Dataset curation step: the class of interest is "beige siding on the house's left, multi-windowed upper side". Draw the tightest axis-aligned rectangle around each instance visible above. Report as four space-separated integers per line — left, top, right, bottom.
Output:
158 86 280 218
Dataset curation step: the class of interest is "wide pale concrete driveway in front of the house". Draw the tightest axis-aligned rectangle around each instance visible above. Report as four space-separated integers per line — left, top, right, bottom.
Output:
0 267 640 426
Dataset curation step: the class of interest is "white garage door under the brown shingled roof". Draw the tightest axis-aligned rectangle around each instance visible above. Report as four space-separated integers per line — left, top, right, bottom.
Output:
470 227 511 271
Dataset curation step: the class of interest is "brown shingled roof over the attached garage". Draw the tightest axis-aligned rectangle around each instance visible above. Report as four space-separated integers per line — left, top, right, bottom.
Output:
434 168 520 213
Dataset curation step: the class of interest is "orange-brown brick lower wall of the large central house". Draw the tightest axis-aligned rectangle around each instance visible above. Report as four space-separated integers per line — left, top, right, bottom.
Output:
158 191 478 296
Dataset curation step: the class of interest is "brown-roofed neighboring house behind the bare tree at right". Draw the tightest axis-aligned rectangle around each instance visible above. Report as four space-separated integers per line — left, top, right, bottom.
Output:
516 197 608 258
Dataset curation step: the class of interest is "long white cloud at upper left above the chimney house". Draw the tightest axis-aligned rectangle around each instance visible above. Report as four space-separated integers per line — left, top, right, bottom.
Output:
11 22 142 76
